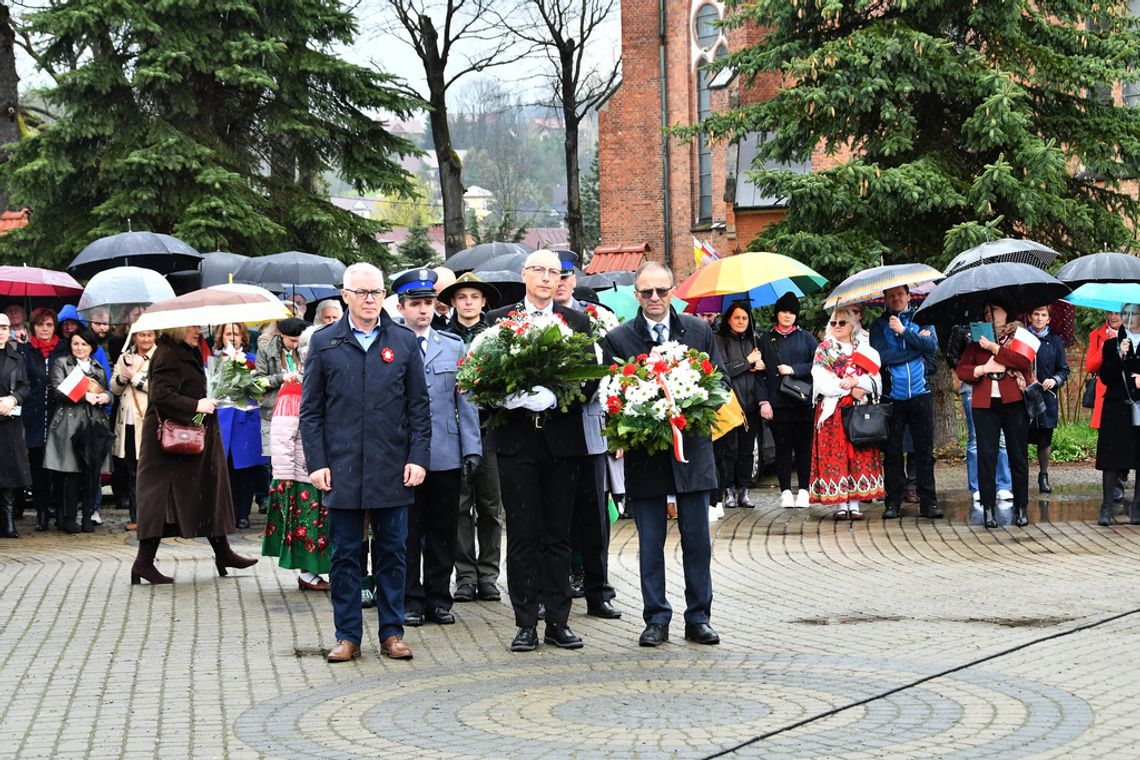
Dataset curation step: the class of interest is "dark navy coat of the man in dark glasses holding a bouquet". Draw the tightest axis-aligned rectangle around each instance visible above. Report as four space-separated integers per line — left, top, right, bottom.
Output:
603 309 727 497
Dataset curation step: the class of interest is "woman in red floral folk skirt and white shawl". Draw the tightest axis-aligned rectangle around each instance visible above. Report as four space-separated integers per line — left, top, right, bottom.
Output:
811 307 884 520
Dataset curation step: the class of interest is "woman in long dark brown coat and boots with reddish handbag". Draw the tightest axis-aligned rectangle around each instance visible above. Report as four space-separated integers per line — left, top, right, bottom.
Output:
131 327 257 583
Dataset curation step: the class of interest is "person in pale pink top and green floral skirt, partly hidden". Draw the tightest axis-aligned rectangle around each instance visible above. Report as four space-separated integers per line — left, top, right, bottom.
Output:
261 327 333 591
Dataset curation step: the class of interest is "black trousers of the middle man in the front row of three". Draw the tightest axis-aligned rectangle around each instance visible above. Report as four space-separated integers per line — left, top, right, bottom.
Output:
498 431 580 628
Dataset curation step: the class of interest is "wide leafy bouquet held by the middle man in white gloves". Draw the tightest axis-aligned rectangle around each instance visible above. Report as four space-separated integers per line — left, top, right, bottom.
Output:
456 311 605 411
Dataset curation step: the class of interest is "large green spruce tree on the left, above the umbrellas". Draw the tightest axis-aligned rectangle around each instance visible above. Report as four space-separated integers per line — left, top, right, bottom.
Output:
0 0 415 265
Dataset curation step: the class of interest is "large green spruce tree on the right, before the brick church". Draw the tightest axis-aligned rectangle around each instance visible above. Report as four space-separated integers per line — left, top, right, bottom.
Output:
693 0 1140 283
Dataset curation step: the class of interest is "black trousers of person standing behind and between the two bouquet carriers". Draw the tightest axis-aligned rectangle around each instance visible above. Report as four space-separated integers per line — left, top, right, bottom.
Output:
570 453 613 606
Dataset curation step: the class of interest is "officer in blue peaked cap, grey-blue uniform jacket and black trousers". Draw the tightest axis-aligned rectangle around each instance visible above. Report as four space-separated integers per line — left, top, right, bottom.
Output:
392 269 483 626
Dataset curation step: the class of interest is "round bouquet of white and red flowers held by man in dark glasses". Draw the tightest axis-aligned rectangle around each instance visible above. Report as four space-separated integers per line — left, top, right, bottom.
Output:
599 341 728 461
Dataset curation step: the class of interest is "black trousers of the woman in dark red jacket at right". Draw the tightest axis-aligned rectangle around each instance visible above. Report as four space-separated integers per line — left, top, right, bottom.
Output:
974 399 1029 507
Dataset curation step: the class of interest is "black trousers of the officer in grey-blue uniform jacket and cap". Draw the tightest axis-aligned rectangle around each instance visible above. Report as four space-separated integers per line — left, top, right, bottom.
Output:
404 469 459 612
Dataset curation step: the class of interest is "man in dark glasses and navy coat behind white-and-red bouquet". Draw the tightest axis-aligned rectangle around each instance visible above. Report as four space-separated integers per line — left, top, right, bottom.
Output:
604 261 727 646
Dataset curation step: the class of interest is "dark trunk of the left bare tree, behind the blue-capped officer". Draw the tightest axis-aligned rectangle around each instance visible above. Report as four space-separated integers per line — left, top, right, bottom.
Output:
420 16 467 258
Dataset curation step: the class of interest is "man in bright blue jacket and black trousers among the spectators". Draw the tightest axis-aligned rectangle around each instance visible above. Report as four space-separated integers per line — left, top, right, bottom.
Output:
871 285 942 520
